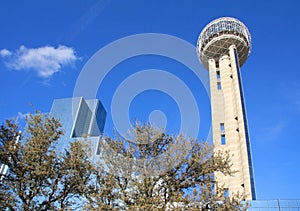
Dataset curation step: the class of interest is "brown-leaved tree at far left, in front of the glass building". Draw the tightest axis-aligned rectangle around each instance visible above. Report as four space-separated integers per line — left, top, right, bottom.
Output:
0 112 94 210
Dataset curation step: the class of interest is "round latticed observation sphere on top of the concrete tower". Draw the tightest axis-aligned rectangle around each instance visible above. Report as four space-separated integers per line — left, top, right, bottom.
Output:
197 17 252 69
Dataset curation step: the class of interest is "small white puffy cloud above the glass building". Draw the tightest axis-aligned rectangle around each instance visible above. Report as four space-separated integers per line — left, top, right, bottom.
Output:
0 45 78 78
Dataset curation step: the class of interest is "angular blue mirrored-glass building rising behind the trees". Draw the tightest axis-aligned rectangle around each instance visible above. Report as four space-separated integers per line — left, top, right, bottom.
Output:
49 97 106 158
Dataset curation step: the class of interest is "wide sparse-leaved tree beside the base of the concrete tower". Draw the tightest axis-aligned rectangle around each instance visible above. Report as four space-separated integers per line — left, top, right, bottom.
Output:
85 124 246 210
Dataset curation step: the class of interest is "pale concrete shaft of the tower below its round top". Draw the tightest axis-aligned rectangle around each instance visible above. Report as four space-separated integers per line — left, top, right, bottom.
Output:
208 45 256 200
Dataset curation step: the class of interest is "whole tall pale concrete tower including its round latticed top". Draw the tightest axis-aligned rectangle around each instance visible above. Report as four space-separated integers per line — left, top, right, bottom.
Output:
197 17 256 200
